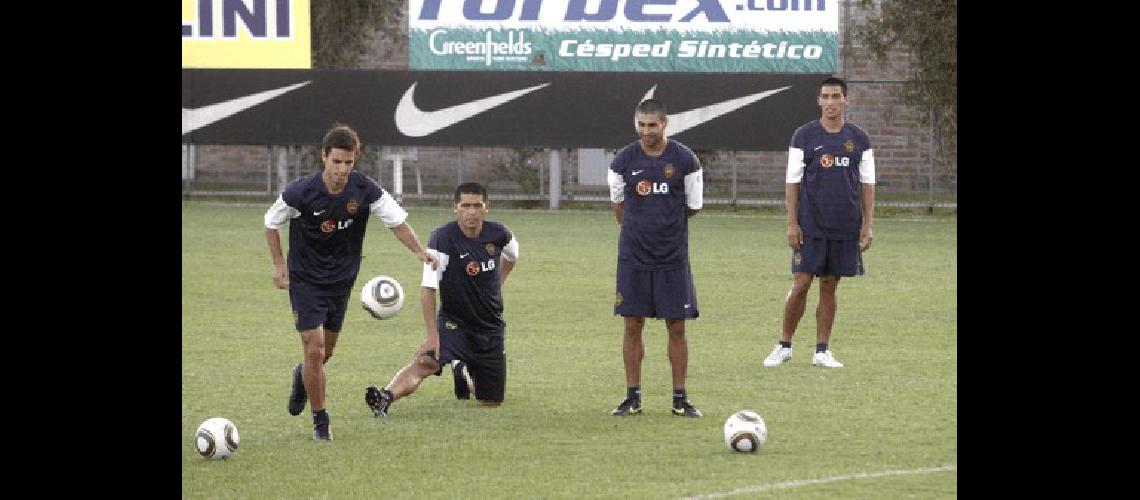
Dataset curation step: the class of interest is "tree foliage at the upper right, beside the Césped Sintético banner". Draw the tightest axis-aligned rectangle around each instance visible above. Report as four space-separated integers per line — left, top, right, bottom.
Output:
850 0 958 149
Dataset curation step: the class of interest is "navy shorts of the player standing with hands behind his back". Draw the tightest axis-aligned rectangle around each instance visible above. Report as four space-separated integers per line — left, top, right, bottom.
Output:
613 262 701 319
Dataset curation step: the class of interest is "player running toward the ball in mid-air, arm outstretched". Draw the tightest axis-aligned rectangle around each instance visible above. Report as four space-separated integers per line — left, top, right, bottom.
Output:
264 124 438 440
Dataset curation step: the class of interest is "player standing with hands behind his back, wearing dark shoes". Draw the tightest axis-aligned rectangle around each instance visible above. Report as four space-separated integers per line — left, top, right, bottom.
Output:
606 99 703 418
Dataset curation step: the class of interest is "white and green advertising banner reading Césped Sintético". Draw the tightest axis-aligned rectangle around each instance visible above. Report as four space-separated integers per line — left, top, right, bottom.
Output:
408 0 839 73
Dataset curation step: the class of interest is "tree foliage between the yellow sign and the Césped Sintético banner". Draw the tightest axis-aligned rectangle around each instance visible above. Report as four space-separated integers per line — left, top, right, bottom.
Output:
310 0 407 69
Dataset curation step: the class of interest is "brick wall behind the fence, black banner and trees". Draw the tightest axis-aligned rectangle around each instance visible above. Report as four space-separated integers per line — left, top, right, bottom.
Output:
186 1 958 198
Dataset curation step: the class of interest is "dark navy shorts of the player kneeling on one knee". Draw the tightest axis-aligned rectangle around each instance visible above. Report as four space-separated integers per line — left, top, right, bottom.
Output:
435 317 506 401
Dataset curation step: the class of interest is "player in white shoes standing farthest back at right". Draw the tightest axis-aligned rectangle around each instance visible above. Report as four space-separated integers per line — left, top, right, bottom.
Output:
764 77 874 368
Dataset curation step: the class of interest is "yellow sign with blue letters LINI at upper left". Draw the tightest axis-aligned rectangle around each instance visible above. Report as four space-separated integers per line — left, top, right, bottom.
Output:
182 0 312 69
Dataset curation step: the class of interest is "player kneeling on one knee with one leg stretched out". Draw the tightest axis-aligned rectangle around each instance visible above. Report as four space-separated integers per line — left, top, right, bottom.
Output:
364 182 519 417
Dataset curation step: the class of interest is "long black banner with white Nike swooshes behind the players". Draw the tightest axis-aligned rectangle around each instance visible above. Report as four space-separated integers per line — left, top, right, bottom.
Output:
182 68 828 150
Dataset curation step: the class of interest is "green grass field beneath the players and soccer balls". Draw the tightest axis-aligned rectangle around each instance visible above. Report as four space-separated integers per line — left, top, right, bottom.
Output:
179 202 958 498
